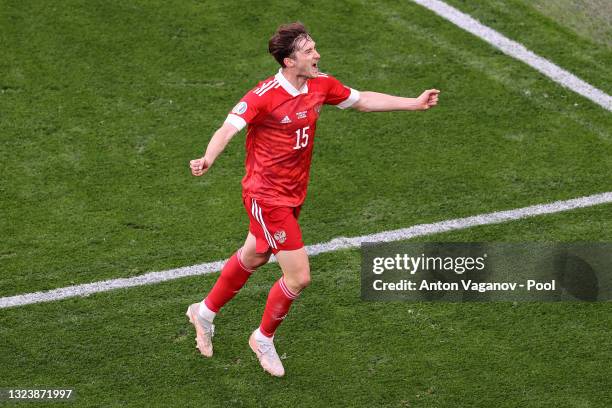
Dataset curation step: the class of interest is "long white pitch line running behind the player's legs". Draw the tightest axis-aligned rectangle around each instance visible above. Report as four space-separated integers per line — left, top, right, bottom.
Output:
0 192 612 309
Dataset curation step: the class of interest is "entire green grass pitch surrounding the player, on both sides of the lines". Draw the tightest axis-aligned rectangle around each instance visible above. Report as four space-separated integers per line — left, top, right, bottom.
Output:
0 1 612 406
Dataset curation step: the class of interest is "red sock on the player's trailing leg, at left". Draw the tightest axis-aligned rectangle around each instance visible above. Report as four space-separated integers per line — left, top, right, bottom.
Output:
204 248 254 313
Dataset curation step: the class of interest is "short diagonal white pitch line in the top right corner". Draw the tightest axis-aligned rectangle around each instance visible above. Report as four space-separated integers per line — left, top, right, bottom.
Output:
412 0 612 111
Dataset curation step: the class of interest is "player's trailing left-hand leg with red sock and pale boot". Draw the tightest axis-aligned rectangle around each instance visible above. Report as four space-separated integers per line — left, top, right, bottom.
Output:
187 232 271 357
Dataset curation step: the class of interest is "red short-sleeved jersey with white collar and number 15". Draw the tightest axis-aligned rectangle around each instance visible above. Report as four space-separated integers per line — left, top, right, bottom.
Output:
226 70 359 207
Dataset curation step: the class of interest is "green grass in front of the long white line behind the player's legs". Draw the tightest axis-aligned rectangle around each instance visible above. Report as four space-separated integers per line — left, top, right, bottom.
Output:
0 206 612 407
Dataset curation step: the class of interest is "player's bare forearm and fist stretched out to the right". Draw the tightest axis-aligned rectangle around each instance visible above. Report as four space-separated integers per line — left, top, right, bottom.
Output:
351 89 440 112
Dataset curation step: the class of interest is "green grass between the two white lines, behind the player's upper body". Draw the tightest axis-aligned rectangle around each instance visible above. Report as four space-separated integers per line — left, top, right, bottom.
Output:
0 2 612 296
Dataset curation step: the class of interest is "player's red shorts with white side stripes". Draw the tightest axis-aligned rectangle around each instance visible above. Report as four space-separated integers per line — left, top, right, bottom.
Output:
242 196 304 254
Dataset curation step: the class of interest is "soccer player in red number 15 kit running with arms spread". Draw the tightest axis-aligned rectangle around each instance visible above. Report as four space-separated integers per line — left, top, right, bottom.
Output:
187 23 439 376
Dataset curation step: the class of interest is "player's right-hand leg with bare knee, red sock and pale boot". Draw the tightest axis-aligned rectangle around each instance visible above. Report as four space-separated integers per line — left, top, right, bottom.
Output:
249 247 310 377
